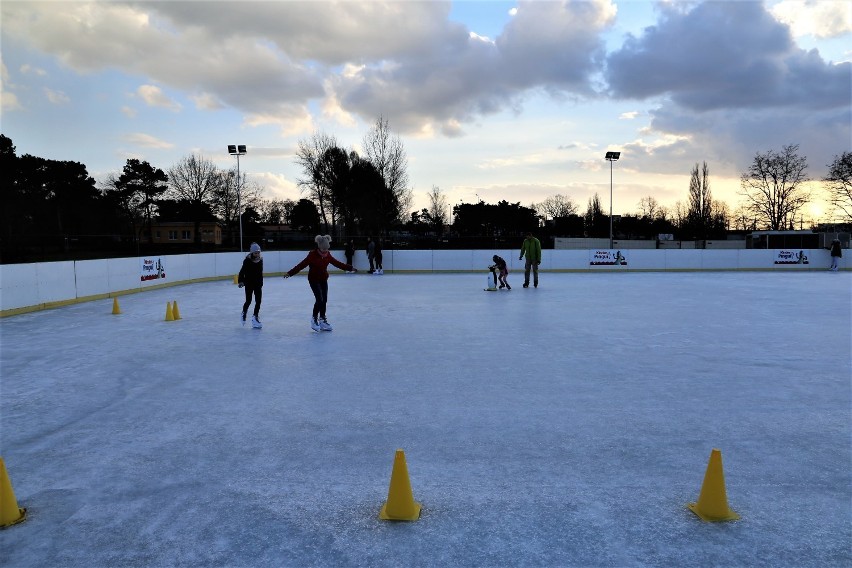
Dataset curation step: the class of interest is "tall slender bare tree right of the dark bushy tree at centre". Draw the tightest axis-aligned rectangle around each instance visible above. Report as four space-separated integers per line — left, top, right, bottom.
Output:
364 116 412 221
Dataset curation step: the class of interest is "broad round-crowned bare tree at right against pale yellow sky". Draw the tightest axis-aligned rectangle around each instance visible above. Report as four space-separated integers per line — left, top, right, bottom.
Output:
740 144 810 231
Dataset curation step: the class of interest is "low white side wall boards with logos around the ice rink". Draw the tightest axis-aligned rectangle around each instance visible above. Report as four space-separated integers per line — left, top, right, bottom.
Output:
0 249 849 317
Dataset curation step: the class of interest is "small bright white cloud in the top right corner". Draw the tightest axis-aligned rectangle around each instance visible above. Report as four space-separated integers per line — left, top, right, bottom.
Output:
770 0 852 38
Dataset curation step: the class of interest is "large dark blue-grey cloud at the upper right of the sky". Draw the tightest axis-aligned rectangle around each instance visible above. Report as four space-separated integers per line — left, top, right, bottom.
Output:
606 2 852 111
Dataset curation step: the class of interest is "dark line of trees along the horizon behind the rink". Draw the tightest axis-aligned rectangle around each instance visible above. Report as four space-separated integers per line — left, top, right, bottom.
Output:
0 123 852 262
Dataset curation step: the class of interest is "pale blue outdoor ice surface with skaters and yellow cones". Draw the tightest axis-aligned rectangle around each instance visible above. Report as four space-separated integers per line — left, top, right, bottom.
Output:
0 271 852 568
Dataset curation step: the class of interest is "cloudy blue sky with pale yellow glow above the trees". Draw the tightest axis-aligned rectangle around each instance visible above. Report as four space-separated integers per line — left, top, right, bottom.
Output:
0 0 852 223
